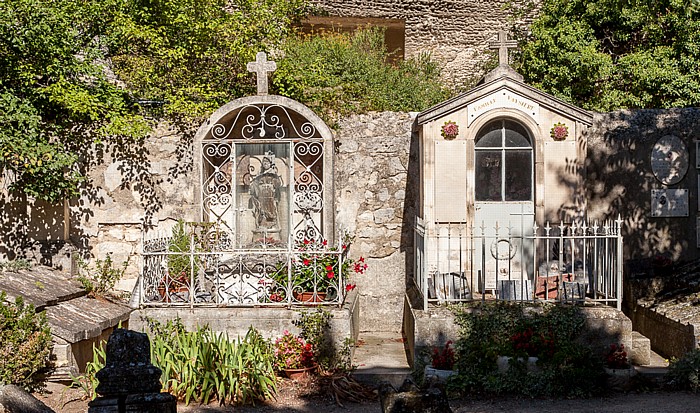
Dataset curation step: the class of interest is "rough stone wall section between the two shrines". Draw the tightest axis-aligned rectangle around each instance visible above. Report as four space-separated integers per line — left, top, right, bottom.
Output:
335 112 419 331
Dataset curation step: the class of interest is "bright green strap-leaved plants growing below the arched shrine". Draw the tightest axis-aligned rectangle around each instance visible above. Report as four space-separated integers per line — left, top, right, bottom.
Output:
151 319 276 404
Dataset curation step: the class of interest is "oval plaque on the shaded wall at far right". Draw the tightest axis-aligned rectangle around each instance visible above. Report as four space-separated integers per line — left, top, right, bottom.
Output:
651 135 688 185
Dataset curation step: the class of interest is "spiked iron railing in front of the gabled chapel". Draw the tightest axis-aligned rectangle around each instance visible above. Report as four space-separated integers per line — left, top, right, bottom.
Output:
414 217 623 309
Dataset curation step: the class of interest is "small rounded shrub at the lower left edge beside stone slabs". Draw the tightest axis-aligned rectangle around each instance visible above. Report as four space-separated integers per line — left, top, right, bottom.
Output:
0 292 52 390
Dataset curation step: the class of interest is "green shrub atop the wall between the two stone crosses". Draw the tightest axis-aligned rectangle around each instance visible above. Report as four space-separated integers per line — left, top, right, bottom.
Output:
272 28 449 125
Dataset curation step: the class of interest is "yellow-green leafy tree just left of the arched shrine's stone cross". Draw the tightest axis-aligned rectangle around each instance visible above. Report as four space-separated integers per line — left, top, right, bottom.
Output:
111 0 307 121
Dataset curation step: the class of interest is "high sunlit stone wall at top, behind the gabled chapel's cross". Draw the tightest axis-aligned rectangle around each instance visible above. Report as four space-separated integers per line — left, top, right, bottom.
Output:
315 0 538 88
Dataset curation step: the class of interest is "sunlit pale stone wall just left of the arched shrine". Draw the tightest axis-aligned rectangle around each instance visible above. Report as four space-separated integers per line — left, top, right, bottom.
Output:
70 123 199 291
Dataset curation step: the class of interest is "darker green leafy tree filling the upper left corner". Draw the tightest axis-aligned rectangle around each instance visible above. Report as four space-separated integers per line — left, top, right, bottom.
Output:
0 0 147 201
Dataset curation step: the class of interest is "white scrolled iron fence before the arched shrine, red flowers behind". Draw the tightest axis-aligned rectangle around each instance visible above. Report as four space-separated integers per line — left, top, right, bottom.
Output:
139 224 351 307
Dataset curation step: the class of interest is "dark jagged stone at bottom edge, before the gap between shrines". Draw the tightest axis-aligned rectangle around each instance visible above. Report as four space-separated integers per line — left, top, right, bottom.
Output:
379 379 452 413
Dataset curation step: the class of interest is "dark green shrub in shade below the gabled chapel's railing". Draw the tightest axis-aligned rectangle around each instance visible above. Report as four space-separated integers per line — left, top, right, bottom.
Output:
449 302 605 397
